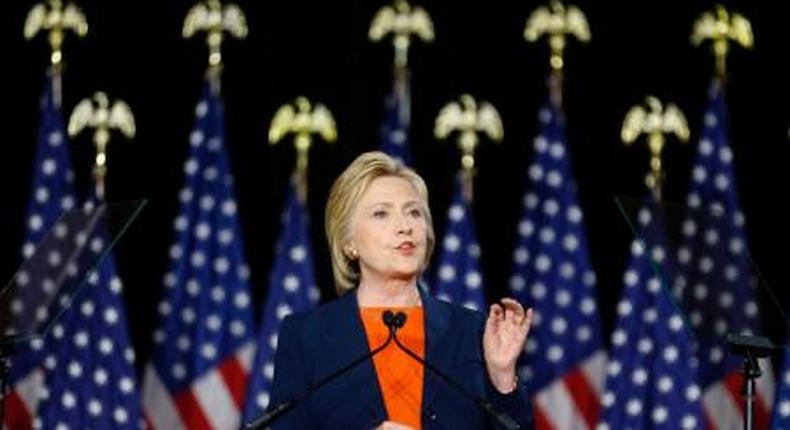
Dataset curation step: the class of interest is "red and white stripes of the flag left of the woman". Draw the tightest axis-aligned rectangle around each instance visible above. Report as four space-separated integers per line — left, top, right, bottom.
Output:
143 342 255 430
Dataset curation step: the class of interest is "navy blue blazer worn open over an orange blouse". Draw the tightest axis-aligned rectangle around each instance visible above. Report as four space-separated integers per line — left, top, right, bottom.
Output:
270 291 532 430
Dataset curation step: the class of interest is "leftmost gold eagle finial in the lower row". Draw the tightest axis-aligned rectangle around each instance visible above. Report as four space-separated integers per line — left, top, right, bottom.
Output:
68 91 135 199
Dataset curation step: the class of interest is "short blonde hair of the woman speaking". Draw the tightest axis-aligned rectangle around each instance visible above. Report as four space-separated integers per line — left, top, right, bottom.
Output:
324 151 436 295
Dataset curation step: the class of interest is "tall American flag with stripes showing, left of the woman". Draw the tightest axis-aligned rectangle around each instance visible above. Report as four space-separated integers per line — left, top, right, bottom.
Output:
143 79 254 430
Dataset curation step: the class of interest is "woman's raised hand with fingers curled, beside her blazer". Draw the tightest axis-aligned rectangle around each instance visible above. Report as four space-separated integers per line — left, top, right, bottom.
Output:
483 298 532 393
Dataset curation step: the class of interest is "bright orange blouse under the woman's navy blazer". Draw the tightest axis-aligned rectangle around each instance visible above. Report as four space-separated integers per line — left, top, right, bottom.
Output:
360 306 425 429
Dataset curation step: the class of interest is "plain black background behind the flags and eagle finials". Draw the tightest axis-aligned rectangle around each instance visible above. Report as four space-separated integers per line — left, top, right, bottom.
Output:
0 0 790 370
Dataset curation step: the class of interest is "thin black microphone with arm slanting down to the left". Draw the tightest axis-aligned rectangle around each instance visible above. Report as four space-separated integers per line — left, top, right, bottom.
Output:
241 310 406 430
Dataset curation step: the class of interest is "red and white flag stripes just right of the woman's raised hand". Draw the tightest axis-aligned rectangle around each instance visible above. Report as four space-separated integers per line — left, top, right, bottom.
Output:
532 351 606 430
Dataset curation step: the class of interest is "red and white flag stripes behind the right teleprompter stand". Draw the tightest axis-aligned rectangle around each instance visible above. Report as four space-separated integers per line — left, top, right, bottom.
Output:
702 360 776 430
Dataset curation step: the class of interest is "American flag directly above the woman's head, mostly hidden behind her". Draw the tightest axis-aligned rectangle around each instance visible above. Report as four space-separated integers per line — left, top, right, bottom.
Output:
381 70 411 165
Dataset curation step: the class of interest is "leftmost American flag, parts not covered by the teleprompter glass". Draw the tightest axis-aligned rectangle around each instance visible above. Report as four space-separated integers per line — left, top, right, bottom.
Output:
5 71 75 429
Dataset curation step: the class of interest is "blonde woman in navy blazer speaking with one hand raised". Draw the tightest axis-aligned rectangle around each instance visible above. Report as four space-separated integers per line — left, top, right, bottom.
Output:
270 152 532 429
